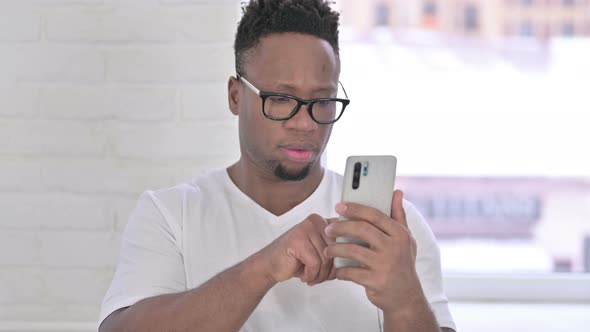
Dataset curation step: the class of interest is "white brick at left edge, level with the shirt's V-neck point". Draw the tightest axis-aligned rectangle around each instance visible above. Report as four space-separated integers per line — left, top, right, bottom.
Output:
0 193 114 230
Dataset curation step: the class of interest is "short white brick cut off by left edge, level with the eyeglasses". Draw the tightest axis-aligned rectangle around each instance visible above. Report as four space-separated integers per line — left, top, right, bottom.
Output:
0 85 39 118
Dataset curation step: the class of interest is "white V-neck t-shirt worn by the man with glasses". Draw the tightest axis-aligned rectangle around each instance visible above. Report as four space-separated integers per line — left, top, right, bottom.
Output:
100 170 455 332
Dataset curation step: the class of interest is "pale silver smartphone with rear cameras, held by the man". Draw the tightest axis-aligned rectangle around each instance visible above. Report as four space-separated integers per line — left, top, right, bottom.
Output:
334 156 397 268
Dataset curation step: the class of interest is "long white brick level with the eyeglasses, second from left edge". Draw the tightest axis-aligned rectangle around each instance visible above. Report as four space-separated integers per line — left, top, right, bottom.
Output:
40 86 177 121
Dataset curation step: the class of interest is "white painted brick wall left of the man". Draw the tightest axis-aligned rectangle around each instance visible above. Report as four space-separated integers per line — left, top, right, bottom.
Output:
0 0 240 331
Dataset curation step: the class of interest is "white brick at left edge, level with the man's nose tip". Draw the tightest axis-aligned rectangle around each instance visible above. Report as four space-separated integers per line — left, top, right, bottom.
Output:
0 120 106 157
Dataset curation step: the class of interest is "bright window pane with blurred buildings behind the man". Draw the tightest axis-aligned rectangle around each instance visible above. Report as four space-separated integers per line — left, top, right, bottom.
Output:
327 0 590 273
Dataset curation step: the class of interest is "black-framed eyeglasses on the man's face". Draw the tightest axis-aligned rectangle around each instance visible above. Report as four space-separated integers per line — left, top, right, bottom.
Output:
237 75 350 125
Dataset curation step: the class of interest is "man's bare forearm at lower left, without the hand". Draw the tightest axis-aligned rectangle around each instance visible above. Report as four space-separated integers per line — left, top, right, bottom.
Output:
99 256 275 332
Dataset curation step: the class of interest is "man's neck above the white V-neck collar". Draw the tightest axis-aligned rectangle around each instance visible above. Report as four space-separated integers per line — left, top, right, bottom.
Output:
227 158 324 216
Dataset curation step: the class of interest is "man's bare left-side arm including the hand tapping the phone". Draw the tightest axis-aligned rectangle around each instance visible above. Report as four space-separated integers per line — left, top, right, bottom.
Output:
99 215 334 332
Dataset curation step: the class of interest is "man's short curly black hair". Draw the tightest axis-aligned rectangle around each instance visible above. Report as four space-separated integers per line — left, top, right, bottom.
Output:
234 0 340 75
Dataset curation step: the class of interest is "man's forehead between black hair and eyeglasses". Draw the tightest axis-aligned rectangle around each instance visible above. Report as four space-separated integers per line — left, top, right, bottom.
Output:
245 33 340 82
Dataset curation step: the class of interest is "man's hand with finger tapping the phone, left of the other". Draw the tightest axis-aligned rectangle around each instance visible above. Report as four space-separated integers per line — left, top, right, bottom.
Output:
257 214 337 286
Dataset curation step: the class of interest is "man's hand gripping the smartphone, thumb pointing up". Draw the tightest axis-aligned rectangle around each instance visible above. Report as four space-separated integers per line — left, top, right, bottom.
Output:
326 190 423 312
